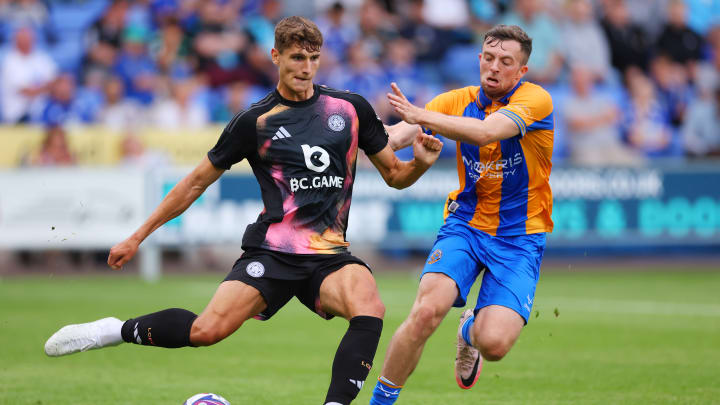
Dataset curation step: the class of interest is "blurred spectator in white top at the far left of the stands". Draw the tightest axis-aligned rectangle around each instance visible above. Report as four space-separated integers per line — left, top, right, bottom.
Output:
0 28 57 124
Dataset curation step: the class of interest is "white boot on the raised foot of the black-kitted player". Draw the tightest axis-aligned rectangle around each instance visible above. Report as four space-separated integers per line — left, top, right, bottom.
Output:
45 318 124 357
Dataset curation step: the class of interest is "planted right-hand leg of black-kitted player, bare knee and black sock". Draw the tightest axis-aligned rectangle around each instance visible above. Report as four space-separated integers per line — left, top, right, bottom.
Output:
319 264 385 405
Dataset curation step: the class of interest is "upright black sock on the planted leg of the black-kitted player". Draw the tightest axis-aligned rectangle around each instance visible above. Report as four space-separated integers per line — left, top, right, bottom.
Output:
325 316 382 404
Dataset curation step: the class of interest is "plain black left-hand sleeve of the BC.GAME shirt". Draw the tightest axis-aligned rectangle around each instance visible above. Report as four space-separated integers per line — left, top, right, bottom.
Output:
208 111 257 170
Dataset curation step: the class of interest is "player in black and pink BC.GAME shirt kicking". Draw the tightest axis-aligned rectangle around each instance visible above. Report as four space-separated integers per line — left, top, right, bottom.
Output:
45 17 442 404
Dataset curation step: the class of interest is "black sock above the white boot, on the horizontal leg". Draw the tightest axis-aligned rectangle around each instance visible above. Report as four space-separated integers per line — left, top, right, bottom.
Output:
122 308 197 348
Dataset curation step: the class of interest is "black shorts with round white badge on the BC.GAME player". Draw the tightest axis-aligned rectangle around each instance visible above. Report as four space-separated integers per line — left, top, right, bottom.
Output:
224 249 370 321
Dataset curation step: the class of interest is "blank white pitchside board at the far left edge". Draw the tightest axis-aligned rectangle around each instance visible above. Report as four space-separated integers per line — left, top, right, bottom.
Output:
0 168 146 249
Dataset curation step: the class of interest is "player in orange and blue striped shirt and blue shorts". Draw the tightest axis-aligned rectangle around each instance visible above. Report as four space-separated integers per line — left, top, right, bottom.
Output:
370 25 553 405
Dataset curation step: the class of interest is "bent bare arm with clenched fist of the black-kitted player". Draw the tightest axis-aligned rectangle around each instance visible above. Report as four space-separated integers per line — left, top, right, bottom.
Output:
369 128 442 189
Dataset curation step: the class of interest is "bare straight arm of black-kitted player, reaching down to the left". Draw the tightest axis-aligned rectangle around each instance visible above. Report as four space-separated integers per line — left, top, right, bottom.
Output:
108 156 225 270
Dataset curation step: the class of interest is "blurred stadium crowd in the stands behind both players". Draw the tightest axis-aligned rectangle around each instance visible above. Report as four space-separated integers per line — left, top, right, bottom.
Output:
0 0 720 165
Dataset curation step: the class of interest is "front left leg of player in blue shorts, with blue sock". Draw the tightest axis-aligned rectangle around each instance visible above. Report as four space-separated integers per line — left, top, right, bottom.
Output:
370 273 458 404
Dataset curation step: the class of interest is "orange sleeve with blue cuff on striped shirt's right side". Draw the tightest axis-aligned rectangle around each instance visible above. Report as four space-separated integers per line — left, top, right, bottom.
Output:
497 84 554 136
